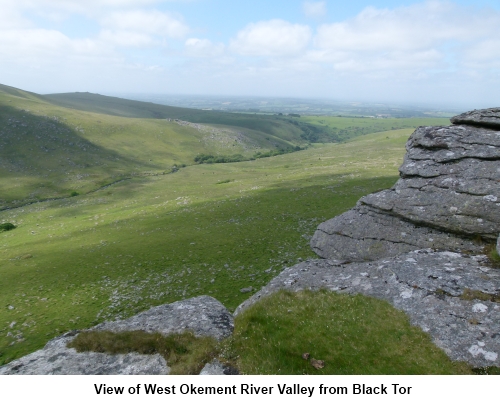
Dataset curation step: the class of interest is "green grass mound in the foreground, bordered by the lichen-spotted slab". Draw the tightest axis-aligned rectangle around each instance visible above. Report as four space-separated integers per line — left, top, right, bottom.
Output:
225 291 472 375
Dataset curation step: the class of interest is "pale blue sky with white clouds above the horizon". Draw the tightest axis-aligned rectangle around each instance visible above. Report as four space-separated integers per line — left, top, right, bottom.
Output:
0 0 500 108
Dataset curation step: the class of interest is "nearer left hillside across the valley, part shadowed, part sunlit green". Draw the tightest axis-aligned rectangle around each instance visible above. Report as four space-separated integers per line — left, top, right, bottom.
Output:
0 86 286 209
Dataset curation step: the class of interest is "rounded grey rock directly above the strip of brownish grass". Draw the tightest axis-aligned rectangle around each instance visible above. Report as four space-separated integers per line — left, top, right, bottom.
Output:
92 295 234 340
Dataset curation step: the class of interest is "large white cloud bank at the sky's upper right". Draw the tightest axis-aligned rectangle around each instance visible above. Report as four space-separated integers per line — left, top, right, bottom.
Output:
314 1 500 74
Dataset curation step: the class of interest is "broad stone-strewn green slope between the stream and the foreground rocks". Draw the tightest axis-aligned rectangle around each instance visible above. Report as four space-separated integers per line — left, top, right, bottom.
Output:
0 130 411 362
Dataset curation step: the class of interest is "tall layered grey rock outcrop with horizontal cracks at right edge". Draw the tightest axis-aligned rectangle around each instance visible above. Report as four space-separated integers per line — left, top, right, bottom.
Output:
311 109 500 261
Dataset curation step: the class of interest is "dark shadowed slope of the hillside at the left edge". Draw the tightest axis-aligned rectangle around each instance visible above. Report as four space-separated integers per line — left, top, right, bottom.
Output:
0 106 157 208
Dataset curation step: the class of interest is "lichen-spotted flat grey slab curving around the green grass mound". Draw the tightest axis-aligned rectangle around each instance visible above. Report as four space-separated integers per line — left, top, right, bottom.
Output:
235 250 500 367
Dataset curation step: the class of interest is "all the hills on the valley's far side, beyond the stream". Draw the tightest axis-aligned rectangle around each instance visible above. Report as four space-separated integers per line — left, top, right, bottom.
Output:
0 85 447 209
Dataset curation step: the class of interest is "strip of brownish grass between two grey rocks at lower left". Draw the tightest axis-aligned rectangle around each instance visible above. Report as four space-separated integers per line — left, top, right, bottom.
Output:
68 331 217 375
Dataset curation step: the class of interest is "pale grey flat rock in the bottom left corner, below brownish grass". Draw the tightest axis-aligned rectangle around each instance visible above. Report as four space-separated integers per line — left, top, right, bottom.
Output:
0 335 170 375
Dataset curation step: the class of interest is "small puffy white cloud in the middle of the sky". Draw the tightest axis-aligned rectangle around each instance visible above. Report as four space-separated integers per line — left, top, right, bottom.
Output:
230 20 312 57
